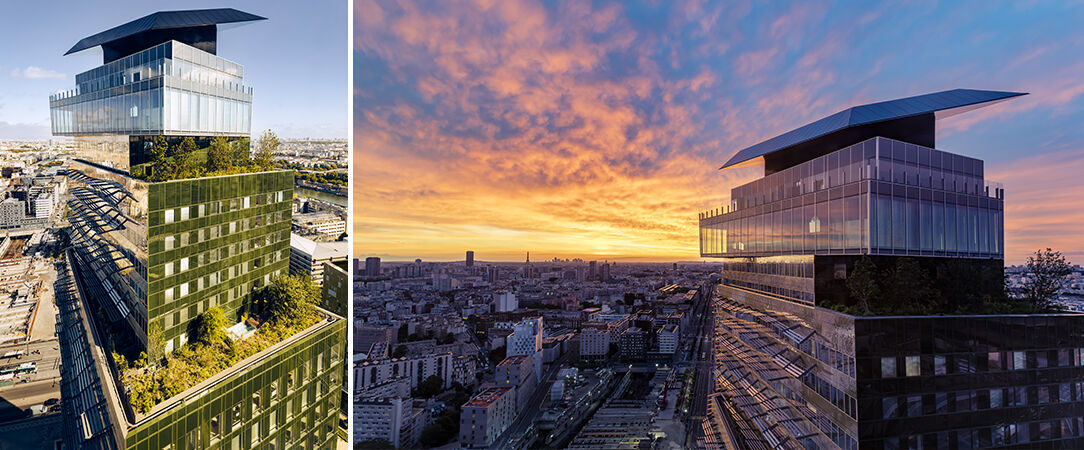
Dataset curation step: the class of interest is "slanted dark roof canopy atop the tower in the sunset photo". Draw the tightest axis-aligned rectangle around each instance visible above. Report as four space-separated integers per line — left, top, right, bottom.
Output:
720 89 1027 175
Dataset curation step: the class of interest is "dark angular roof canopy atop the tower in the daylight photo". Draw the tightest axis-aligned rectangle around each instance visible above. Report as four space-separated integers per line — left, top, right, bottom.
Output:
64 8 267 64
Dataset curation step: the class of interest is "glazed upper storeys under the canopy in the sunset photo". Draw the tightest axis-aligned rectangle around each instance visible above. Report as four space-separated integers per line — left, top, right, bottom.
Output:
700 138 1004 259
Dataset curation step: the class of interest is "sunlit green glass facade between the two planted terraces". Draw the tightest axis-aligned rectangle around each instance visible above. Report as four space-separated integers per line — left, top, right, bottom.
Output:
146 171 294 350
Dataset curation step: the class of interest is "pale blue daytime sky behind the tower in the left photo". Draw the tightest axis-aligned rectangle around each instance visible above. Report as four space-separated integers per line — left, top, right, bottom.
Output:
0 0 349 139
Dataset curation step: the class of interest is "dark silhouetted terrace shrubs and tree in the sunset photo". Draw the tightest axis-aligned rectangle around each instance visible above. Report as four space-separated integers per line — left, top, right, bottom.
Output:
821 248 1071 316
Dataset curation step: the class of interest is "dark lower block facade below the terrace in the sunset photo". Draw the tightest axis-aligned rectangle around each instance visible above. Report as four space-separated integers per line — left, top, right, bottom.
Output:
854 314 1084 449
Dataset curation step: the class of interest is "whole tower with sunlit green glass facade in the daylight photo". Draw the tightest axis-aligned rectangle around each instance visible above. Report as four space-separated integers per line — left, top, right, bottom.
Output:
50 9 346 449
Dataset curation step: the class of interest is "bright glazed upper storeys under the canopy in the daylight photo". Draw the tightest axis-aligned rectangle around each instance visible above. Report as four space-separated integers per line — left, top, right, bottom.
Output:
49 41 253 137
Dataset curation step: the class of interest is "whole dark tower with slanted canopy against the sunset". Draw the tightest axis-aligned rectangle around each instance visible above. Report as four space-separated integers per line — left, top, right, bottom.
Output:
694 89 1084 449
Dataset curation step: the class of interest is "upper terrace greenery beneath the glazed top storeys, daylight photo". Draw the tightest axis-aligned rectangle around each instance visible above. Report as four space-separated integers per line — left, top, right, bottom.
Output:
129 130 282 182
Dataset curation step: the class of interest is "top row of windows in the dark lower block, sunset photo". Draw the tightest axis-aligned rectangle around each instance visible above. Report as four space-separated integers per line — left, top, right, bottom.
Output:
880 348 1084 378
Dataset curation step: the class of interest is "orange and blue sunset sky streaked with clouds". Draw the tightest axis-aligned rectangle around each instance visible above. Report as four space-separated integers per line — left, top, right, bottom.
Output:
353 0 1084 263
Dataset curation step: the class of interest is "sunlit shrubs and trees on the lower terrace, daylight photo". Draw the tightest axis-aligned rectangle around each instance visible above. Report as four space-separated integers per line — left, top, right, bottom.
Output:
114 275 322 414
